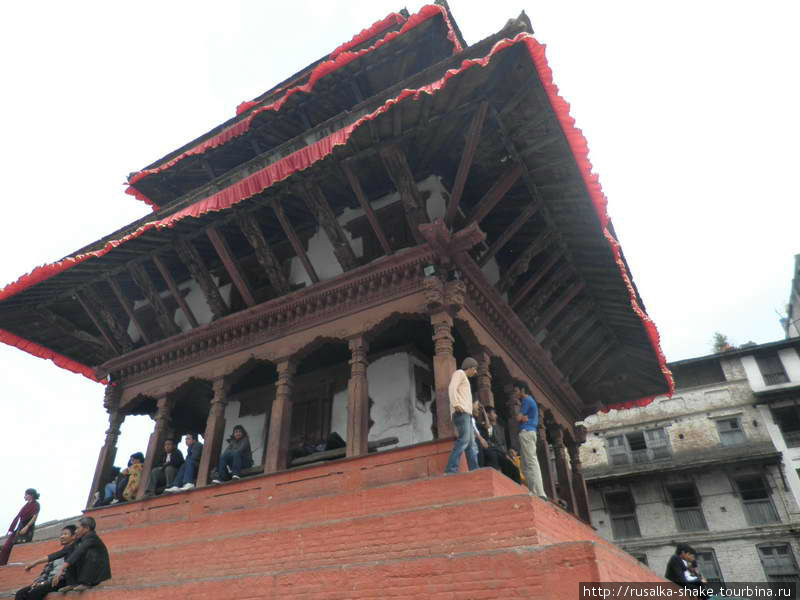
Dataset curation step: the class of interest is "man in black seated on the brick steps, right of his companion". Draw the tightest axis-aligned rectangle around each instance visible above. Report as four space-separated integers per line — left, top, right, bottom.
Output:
56 517 111 592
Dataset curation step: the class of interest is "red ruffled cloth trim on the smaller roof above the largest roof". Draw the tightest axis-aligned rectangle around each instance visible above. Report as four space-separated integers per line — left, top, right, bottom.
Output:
126 4 461 206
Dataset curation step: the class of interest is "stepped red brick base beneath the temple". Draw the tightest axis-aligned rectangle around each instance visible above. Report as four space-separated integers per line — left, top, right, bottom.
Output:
0 441 659 600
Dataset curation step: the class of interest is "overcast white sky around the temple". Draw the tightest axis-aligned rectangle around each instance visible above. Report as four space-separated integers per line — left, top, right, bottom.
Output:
0 0 800 524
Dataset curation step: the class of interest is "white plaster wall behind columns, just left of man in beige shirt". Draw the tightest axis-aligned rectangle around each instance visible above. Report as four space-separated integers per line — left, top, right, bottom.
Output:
331 352 433 449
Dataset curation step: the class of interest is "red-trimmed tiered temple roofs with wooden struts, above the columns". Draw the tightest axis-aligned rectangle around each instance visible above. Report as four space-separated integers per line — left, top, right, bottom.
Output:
0 4 671 418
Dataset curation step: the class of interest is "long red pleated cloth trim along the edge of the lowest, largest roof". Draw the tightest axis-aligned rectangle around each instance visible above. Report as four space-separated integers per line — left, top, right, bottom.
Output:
0 34 674 394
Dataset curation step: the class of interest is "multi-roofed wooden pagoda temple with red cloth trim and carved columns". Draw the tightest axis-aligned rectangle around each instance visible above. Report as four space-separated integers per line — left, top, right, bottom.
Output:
0 3 672 598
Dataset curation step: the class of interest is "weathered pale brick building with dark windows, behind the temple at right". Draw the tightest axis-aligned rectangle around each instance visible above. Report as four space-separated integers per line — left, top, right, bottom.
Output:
581 338 800 581
